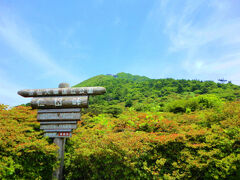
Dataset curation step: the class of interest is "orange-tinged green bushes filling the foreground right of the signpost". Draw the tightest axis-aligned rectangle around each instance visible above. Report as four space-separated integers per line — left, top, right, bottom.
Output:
65 102 240 179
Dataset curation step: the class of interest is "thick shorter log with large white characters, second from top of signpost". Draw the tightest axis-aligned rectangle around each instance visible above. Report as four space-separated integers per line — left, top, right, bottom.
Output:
31 96 88 109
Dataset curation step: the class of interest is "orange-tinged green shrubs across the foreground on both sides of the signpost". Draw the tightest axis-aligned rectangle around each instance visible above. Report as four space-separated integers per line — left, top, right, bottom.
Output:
0 96 240 179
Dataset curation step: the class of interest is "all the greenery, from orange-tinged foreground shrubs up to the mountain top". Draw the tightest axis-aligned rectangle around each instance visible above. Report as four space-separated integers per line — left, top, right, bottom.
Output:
0 73 240 180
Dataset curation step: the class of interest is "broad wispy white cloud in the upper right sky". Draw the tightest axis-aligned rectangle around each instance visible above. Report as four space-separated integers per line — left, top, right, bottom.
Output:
154 0 240 84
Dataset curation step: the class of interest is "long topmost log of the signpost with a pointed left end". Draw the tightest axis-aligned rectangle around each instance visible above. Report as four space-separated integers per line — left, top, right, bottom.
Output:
18 87 106 97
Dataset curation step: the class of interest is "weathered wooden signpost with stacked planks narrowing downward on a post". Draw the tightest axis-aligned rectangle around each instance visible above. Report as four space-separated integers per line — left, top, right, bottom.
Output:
18 83 106 180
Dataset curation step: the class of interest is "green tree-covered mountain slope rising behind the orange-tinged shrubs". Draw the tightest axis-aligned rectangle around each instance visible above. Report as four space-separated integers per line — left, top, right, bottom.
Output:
74 72 240 114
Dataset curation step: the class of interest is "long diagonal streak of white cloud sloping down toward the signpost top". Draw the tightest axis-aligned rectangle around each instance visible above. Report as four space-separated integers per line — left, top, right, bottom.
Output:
0 10 77 81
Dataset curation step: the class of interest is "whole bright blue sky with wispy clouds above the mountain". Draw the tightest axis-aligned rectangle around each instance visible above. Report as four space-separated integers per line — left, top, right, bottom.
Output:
0 0 240 106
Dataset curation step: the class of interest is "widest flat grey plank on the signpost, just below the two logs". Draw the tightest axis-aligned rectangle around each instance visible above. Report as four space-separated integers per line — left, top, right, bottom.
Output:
37 113 81 121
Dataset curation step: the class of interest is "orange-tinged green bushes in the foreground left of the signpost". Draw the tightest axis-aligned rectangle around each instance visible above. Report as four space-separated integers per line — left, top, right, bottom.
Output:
0 105 57 179
